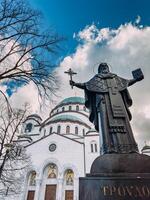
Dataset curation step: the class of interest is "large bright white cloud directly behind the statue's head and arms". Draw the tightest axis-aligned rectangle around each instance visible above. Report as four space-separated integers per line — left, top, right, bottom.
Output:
57 21 150 150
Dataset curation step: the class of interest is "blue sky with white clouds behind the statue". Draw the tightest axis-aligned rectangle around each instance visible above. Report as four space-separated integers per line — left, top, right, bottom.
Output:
8 0 150 149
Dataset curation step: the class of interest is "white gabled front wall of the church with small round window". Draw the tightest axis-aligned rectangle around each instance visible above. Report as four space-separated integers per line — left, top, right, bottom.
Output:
22 134 85 200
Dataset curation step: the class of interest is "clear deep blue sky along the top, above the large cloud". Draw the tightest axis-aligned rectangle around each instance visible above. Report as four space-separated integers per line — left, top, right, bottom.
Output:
30 0 150 54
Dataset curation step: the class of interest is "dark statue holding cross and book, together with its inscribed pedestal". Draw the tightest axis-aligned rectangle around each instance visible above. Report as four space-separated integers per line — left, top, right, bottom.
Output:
68 63 150 200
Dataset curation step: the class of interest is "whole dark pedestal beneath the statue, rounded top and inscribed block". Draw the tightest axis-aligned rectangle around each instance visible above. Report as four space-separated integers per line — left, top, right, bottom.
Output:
79 153 150 200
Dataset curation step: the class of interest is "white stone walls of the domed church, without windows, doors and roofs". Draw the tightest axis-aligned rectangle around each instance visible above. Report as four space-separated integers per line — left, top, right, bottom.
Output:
12 97 100 200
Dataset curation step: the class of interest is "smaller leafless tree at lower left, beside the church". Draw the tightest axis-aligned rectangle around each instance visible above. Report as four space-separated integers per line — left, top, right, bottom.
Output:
0 98 30 196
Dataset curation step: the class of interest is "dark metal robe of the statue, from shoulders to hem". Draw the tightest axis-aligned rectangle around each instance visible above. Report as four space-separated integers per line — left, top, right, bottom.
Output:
85 73 138 153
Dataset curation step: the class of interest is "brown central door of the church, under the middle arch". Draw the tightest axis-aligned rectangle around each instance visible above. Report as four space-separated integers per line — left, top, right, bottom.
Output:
45 185 56 200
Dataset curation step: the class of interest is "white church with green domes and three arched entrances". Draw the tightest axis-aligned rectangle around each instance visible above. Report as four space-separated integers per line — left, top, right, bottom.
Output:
19 97 100 200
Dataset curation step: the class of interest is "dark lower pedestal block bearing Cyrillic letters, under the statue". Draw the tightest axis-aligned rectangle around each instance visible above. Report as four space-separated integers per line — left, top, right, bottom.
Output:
79 177 150 200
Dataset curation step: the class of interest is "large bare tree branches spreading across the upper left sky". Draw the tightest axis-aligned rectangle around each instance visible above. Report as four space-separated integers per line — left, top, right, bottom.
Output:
0 0 62 104
